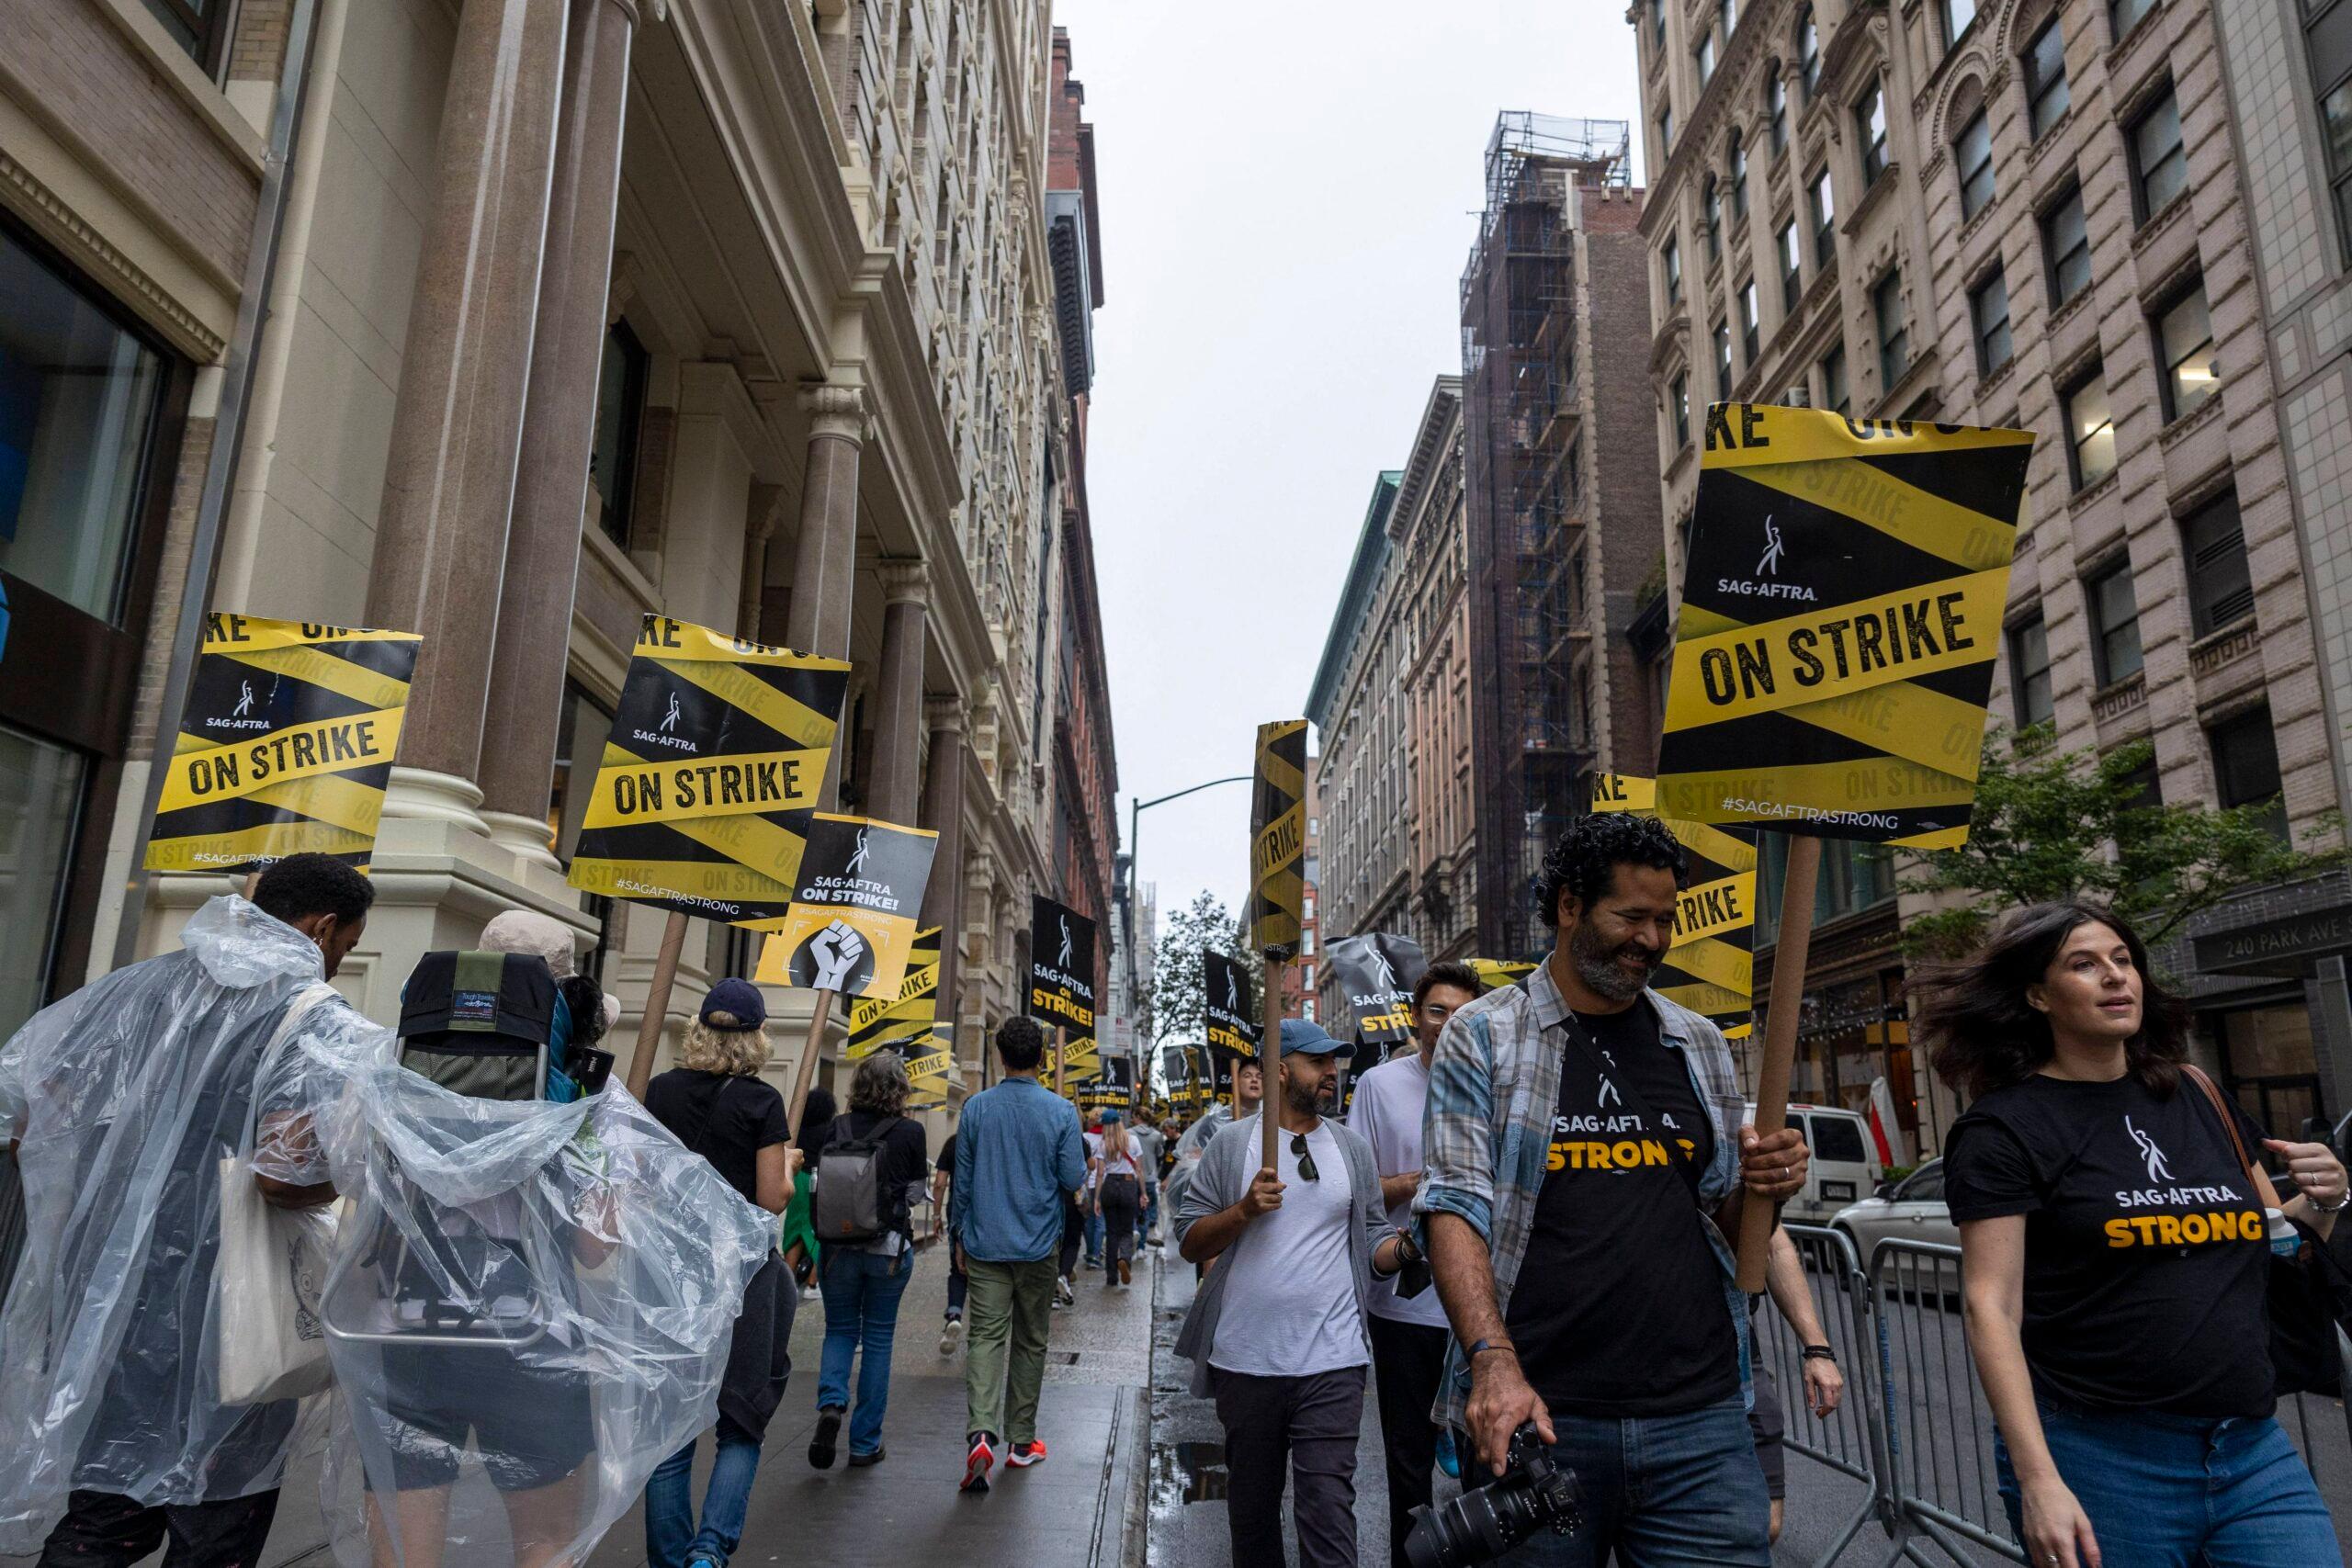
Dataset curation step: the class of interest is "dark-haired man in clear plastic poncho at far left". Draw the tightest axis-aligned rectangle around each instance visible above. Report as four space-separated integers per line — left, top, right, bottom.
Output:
0 856 383 1568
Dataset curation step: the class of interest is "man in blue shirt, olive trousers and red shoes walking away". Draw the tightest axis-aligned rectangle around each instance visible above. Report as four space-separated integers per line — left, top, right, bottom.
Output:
948 1018 1087 1493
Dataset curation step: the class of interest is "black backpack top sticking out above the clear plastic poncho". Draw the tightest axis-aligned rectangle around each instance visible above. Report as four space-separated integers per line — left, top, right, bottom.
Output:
400 952 571 1100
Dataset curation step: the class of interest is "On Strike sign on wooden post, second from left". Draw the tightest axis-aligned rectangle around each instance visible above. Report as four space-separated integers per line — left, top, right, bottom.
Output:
571 616 849 1100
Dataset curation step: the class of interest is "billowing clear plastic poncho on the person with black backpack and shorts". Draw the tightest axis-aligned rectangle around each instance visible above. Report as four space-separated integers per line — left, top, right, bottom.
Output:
270 987 774 1568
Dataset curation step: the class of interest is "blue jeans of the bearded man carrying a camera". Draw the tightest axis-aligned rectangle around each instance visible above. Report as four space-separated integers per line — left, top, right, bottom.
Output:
1505 1394 1769 1568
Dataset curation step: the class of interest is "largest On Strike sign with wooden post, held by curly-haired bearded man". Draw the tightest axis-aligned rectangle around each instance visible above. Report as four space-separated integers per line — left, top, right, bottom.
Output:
1656 402 2034 1291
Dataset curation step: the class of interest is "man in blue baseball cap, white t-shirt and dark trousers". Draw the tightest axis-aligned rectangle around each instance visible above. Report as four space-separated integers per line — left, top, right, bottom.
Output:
1176 1018 1419 1568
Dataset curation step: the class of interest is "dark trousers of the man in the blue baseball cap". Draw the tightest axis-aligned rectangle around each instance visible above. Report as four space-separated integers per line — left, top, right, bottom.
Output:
1209 1366 1364 1568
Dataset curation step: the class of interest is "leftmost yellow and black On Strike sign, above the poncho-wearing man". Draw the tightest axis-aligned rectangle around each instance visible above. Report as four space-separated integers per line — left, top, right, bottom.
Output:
146 611 421 872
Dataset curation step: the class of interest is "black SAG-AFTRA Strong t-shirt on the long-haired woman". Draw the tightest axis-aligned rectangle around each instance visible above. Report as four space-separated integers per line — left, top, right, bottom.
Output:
1943 1075 2275 1417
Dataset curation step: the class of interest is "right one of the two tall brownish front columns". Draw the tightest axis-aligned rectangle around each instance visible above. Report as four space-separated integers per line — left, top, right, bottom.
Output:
482 0 638 870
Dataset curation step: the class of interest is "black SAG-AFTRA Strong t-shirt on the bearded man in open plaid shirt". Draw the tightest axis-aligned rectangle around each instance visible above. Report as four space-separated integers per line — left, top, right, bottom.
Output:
1503 1001 1740 1417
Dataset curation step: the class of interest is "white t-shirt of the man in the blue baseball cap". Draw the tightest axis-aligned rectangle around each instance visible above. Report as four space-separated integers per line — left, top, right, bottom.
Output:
1209 1117 1371 1378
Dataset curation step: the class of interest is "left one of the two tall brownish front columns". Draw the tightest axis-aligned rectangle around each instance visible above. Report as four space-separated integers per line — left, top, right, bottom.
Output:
367 0 564 829
